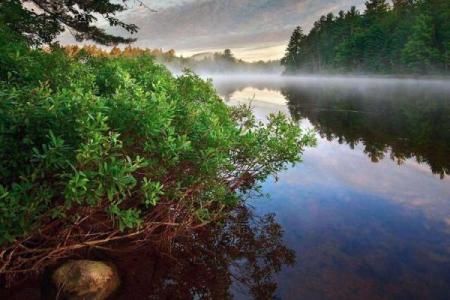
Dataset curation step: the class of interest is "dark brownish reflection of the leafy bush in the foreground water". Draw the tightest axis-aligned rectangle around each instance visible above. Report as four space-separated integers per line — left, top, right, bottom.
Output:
115 207 295 299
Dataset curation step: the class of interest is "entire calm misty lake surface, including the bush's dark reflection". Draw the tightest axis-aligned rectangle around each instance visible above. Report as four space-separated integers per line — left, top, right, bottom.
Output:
113 76 450 300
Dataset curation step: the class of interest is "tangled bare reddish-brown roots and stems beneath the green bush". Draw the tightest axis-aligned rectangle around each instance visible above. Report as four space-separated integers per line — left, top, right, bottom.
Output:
0 201 218 285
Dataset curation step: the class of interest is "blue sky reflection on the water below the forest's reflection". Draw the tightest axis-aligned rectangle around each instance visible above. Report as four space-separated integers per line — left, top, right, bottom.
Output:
254 172 450 300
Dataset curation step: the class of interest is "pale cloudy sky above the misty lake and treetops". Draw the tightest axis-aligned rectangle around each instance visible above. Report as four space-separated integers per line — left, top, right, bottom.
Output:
63 0 365 61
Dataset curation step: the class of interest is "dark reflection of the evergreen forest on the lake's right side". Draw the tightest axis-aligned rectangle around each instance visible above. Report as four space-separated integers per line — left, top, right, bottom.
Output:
282 87 450 178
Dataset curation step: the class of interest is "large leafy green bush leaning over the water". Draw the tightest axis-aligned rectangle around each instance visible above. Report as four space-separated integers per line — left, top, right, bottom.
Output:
0 25 313 260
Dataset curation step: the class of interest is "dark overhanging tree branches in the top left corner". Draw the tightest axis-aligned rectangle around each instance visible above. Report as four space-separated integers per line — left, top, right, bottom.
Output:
0 0 142 45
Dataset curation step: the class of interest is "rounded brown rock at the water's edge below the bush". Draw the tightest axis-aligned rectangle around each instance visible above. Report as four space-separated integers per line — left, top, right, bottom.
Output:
52 260 120 300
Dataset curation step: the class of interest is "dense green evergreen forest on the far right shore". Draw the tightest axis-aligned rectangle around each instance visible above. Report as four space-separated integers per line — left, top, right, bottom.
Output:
282 0 450 74
